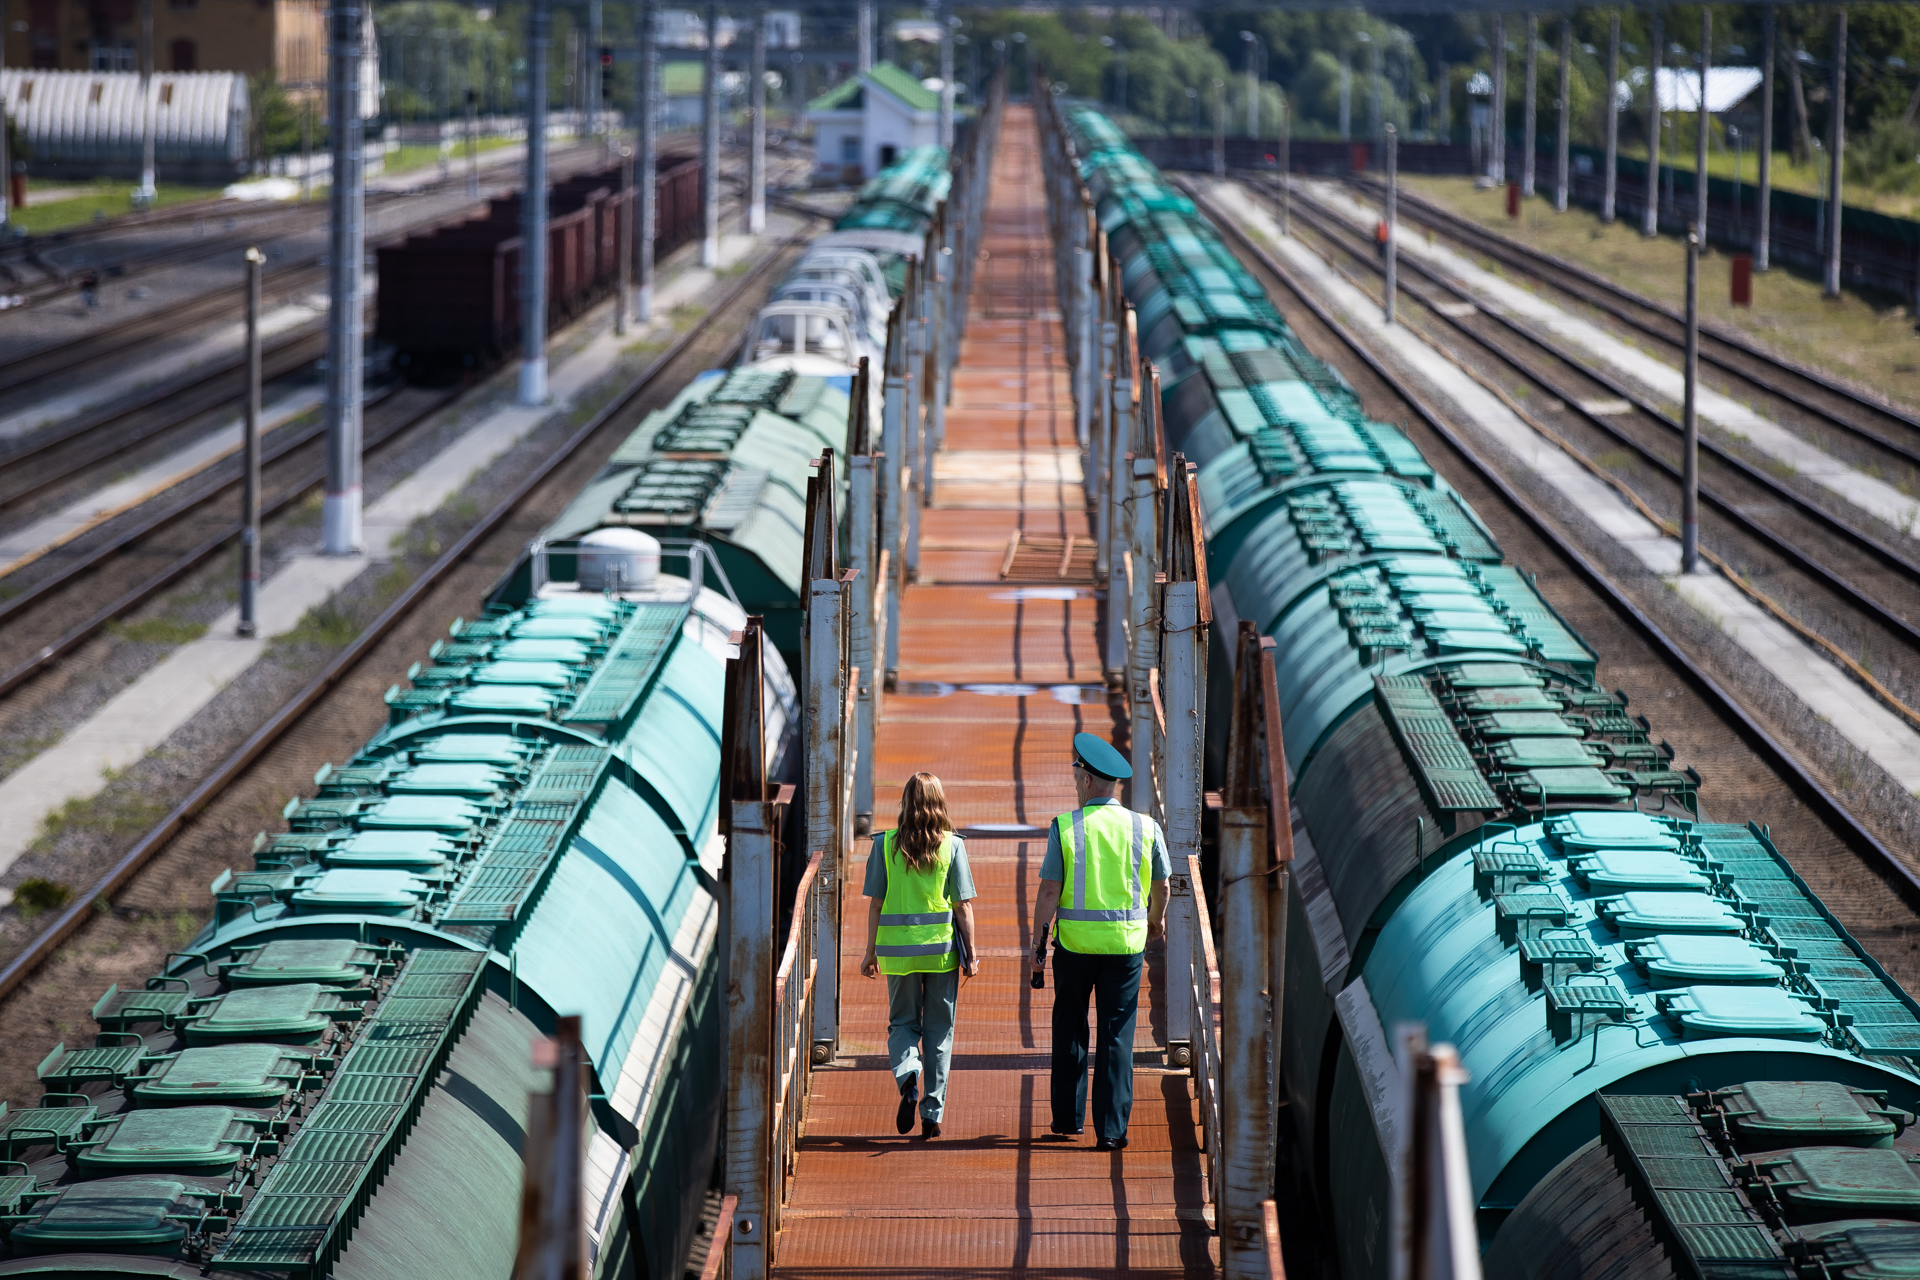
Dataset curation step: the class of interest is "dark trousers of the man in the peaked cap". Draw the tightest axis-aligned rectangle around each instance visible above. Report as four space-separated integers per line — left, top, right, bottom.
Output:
1052 946 1140 1140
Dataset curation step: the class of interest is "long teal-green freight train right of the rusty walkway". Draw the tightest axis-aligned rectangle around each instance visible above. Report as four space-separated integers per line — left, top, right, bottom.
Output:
1058 107 1920 1280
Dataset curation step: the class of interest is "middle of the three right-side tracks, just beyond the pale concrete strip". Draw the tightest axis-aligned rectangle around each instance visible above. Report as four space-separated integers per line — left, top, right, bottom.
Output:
1267 186 1920 727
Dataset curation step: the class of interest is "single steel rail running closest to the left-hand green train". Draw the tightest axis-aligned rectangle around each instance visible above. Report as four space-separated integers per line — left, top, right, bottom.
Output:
0 240 797 1000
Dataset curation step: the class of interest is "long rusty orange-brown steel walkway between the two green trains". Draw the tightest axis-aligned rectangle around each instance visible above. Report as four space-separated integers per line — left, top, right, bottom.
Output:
774 106 1217 1280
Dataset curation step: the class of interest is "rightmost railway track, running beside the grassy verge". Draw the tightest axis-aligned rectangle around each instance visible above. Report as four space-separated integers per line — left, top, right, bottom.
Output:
1356 180 1920 495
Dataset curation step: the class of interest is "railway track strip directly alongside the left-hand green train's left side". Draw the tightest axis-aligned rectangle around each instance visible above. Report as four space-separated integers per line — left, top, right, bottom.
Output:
0 242 797 1000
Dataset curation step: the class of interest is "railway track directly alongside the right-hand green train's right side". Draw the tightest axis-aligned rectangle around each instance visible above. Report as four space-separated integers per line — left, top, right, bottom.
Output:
1194 180 1920 967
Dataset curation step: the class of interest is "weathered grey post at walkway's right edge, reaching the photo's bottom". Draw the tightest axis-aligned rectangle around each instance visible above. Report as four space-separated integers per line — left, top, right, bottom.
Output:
1219 808 1273 1276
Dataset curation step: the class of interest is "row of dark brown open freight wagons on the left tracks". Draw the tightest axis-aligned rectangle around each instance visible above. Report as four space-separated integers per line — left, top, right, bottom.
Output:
374 155 701 380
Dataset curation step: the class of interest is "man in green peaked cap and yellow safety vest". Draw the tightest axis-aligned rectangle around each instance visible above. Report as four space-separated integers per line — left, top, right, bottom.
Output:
1033 733 1173 1151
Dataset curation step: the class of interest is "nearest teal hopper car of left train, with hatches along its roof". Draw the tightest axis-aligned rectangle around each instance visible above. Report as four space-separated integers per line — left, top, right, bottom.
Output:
0 543 797 1280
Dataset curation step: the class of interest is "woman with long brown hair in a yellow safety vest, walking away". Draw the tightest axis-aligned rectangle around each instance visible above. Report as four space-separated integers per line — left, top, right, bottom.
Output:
860 773 979 1138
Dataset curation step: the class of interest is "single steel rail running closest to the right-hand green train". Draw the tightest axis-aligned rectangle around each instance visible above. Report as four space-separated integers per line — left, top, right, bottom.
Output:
1179 182 1920 910
